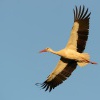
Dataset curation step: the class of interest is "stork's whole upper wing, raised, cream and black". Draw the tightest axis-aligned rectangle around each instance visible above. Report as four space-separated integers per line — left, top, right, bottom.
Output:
66 6 91 53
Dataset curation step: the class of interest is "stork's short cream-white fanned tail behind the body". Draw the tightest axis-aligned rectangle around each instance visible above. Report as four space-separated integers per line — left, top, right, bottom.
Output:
77 53 90 67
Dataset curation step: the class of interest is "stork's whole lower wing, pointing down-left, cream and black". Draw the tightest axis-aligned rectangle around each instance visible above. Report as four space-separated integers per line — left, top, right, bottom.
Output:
36 57 77 92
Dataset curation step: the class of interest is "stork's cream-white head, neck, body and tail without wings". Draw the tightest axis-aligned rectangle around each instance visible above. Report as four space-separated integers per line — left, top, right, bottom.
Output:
48 48 90 67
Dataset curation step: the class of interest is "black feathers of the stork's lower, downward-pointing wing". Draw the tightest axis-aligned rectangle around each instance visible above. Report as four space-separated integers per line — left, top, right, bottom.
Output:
37 57 77 92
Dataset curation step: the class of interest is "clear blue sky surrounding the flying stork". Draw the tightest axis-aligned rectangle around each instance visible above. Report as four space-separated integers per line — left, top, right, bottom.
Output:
0 0 100 100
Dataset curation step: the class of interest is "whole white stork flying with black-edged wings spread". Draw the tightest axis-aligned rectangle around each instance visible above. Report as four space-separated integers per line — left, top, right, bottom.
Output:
36 6 97 92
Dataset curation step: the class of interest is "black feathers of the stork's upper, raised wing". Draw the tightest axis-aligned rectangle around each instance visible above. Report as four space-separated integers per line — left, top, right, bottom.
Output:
74 6 91 53
